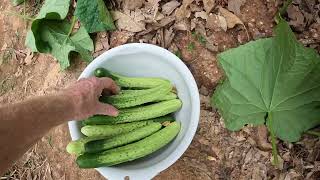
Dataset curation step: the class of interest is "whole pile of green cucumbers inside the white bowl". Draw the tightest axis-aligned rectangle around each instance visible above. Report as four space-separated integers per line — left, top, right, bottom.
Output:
67 68 182 168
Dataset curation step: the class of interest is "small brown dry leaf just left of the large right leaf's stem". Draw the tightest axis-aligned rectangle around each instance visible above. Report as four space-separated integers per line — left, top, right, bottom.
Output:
253 125 272 151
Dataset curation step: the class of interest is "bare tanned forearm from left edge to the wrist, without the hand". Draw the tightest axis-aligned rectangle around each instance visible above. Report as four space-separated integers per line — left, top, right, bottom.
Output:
0 94 76 173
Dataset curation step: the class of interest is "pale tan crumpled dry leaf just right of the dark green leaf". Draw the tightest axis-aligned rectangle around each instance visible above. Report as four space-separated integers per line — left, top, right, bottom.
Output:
111 10 146 32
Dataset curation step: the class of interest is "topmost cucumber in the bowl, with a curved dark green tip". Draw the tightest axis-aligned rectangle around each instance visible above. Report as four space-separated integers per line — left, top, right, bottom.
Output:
94 68 169 89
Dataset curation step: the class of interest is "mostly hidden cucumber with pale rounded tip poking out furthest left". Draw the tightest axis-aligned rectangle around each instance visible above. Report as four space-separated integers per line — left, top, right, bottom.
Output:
66 137 105 155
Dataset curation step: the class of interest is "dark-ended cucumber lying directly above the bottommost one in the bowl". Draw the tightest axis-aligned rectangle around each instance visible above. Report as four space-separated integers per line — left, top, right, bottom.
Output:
85 122 162 153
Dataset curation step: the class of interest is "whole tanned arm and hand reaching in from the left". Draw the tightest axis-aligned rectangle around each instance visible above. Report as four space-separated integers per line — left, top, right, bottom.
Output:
0 77 119 174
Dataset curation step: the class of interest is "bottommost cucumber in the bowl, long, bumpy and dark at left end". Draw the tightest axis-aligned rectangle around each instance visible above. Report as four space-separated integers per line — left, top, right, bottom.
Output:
77 122 181 168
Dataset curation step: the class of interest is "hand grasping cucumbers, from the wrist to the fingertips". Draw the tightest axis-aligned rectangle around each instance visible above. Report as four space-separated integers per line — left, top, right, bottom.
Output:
64 77 120 120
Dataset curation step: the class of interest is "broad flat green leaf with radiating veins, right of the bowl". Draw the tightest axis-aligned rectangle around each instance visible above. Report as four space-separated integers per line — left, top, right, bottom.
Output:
212 20 320 142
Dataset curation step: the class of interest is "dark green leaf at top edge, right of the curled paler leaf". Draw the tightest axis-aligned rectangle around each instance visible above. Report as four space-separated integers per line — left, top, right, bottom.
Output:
75 0 116 33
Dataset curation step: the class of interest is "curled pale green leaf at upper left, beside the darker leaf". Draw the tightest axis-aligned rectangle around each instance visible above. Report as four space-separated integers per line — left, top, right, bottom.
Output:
26 0 94 69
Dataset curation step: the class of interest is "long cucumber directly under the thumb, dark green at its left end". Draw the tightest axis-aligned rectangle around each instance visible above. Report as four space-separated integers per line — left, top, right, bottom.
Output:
82 99 182 125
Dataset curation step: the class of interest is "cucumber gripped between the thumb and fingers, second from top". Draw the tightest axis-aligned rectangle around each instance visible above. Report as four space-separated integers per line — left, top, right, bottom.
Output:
100 83 172 109
